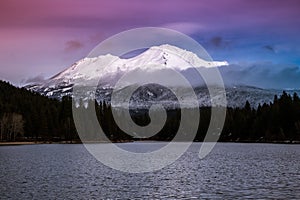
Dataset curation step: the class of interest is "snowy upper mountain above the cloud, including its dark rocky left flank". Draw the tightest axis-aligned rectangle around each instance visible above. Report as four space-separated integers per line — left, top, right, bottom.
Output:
26 44 228 99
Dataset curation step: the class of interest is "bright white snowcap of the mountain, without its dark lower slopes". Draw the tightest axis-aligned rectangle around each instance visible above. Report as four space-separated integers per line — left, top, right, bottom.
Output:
47 44 228 85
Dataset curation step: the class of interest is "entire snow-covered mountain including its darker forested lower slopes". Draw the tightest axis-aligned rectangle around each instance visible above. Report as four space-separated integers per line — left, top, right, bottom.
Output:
26 45 296 107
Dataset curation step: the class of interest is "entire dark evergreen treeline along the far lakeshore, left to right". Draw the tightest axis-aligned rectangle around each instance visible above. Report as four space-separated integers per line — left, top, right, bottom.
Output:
0 82 300 142
